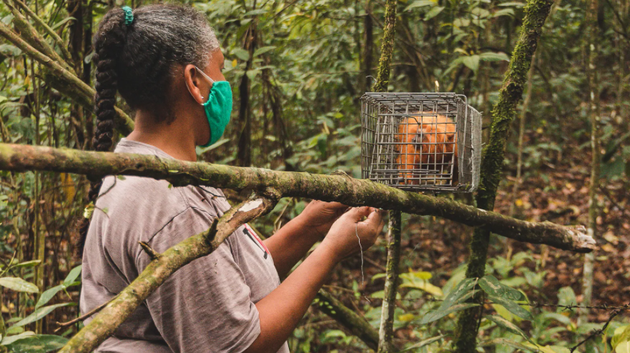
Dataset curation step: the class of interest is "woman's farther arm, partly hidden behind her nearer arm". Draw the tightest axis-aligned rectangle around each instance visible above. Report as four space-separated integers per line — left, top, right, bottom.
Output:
265 201 348 278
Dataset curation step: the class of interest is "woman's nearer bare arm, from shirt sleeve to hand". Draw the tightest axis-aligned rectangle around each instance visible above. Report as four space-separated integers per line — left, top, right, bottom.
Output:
245 207 383 353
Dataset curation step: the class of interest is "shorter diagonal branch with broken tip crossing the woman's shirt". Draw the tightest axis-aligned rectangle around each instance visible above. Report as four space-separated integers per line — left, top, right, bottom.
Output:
59 195 277 353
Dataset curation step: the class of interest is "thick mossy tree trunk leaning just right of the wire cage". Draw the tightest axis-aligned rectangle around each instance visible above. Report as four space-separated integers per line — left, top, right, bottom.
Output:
455 0 552 353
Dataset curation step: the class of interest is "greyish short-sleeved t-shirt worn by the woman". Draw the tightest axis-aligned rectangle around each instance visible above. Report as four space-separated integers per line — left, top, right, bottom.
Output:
80 139 289 353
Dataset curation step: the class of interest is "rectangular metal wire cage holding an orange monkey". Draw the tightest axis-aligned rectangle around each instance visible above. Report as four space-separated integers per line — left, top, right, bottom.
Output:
361 92 481 192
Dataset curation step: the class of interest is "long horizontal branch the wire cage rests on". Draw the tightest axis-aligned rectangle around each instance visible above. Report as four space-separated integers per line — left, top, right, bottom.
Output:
0 144 595 253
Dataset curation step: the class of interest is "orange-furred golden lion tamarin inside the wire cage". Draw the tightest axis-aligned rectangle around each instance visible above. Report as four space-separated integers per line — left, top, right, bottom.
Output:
395 115 457 184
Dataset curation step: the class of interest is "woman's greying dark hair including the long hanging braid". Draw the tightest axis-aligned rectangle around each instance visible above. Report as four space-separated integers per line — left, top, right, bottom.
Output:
77 4 219 254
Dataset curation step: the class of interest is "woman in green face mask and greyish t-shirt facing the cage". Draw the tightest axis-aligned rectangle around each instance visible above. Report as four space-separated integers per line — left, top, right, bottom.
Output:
81 5 383 353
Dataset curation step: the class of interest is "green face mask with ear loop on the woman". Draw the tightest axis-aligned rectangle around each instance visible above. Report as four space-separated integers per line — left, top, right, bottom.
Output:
189 66 232 147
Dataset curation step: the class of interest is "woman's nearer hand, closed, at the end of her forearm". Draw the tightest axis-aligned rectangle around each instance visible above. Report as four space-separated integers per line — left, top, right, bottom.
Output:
321 207 385 261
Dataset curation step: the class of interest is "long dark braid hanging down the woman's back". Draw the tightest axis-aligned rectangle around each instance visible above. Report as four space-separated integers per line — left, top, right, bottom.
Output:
77 9 127 255
